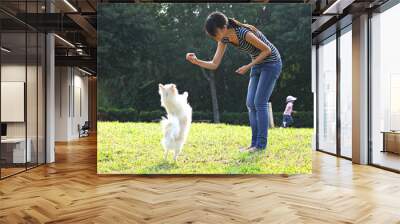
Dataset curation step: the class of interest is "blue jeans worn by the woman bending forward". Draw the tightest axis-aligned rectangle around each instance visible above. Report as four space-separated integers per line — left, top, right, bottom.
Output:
246 62 282 149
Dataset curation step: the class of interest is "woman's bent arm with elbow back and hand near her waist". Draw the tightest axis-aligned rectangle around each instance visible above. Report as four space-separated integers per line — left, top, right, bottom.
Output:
236 32 271 75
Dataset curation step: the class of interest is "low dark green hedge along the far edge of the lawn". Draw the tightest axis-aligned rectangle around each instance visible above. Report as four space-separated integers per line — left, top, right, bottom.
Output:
98 108 313 127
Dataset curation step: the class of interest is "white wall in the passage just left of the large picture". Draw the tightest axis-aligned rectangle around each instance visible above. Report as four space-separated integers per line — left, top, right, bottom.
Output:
55 67 89 141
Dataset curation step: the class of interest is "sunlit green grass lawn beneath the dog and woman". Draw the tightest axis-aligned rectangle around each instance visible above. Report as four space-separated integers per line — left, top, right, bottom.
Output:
97 122 312 174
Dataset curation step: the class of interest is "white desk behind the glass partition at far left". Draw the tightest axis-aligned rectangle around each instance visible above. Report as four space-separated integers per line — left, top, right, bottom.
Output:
1 138 32 163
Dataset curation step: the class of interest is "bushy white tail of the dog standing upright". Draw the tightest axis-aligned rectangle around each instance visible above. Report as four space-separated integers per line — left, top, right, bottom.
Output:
161 116 180 149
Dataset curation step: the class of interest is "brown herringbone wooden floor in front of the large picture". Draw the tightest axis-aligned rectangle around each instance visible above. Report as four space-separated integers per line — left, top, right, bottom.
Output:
0 134 400 224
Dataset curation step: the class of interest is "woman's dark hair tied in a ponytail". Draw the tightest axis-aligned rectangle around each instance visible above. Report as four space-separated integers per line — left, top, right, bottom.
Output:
204 12 257 37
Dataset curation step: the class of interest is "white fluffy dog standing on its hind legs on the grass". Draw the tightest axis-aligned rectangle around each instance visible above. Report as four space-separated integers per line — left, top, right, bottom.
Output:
158 84 192 161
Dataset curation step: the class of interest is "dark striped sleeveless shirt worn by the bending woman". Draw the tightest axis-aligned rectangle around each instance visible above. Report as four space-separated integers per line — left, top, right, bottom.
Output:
222 26 281 64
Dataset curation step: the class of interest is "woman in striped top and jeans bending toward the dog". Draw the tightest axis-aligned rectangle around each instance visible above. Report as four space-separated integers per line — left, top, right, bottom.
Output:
186 12 282 152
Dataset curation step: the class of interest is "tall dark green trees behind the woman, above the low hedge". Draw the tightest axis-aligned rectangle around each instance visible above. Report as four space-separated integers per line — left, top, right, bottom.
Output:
98 3 313 114
